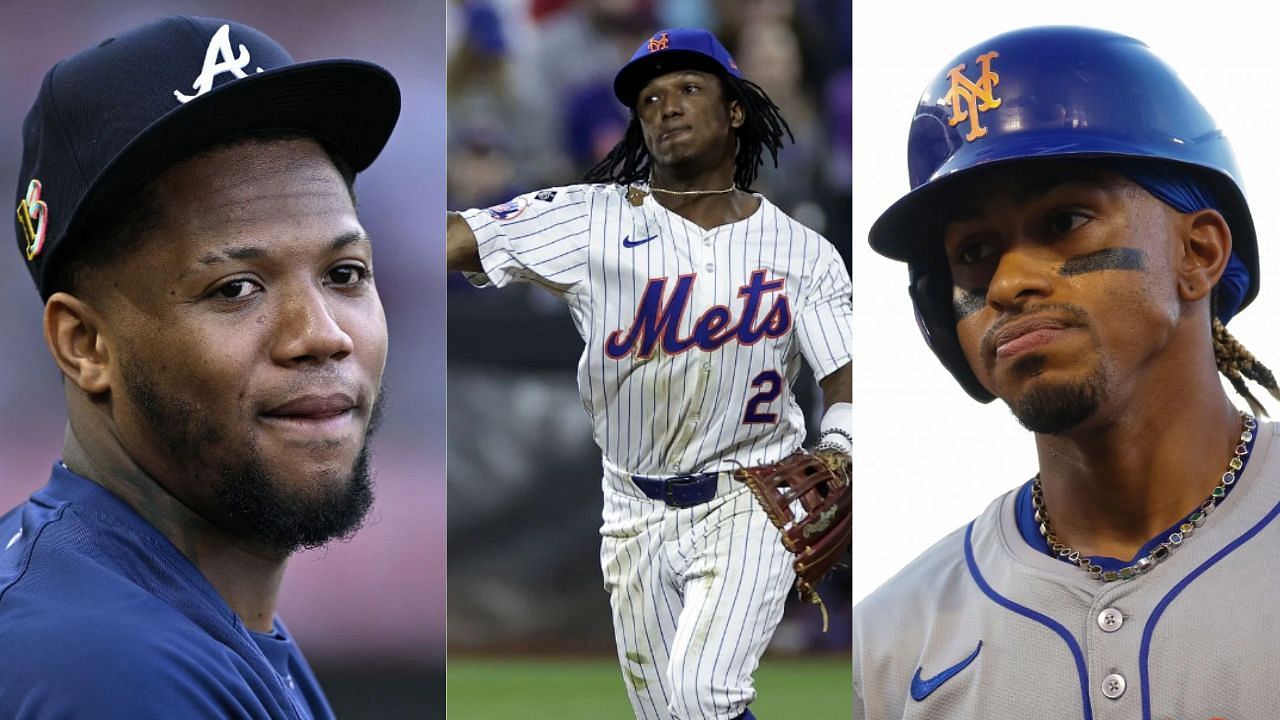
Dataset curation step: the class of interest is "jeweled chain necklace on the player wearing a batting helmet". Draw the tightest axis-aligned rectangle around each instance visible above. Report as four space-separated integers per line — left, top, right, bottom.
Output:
1032 413 1258 583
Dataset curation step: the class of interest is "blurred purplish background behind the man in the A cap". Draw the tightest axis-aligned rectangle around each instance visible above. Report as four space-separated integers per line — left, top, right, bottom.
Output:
0 0 445 720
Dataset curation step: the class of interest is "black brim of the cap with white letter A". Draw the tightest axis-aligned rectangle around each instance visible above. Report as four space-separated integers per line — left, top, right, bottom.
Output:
53 60 401 279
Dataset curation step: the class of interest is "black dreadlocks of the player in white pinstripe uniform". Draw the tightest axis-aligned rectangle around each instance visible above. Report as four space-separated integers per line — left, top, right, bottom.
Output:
582 76 796 190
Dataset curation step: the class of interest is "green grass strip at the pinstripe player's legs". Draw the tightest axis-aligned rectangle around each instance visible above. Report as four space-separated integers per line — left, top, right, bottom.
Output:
445 656 852 720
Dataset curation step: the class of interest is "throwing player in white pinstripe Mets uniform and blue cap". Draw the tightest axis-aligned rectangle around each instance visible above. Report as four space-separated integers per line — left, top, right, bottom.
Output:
448 28 851 720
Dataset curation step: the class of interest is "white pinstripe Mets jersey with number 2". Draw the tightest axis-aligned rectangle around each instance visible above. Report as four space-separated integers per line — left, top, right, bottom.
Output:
462 184 852 475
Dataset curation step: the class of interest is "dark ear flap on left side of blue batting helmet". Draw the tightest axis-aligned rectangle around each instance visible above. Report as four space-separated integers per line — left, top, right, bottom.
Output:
908 260 996 402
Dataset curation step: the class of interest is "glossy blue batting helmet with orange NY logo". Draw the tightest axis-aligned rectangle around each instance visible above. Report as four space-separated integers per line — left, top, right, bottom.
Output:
869 27 1258 402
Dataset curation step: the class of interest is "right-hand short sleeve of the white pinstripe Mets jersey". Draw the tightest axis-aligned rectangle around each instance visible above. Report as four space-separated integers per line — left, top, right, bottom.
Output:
796 238 854 379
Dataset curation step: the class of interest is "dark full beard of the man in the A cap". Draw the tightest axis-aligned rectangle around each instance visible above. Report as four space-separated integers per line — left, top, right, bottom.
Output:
124 365 384 556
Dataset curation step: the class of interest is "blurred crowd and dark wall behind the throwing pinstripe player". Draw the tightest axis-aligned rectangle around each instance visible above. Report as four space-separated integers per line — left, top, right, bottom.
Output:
445 0 851 661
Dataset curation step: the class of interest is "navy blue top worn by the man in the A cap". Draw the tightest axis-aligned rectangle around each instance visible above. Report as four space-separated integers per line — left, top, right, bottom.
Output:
0 462 333 720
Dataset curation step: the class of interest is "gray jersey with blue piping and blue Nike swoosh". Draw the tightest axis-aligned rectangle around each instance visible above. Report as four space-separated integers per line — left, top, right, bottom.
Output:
854 423 1280 720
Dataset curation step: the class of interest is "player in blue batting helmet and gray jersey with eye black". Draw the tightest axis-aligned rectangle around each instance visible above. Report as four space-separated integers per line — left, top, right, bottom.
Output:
854 27 1280 720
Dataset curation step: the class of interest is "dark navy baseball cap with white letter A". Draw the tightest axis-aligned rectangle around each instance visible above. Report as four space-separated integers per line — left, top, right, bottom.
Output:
17 17 401 300
